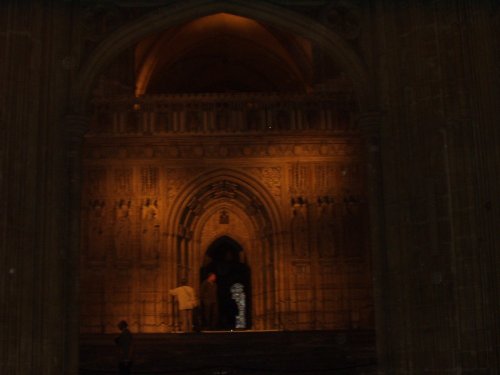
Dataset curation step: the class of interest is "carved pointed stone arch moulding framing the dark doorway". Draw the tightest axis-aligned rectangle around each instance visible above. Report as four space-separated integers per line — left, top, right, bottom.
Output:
169 169 284 329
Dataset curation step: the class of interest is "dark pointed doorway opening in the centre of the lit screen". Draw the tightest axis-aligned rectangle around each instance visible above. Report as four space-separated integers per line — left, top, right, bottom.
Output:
200 236 252 330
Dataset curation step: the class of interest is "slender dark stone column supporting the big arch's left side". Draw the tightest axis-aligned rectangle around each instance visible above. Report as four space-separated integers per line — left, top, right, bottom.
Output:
63 114 90 375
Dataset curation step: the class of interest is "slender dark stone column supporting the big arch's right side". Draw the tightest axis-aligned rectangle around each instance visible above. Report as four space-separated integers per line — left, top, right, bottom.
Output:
358 112 390 374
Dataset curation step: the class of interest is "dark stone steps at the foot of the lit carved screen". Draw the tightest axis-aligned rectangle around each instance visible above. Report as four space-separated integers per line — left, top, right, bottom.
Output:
80 330 376 375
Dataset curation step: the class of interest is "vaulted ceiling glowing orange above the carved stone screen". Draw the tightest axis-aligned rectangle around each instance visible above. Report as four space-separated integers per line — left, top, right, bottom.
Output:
135 13 313 96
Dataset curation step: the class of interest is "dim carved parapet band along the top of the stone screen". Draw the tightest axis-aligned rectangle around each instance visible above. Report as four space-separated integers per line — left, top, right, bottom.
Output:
91 93 355 135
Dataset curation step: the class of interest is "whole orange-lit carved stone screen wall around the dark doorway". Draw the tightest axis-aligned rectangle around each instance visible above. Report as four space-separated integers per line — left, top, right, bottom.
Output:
80 95 373 333
